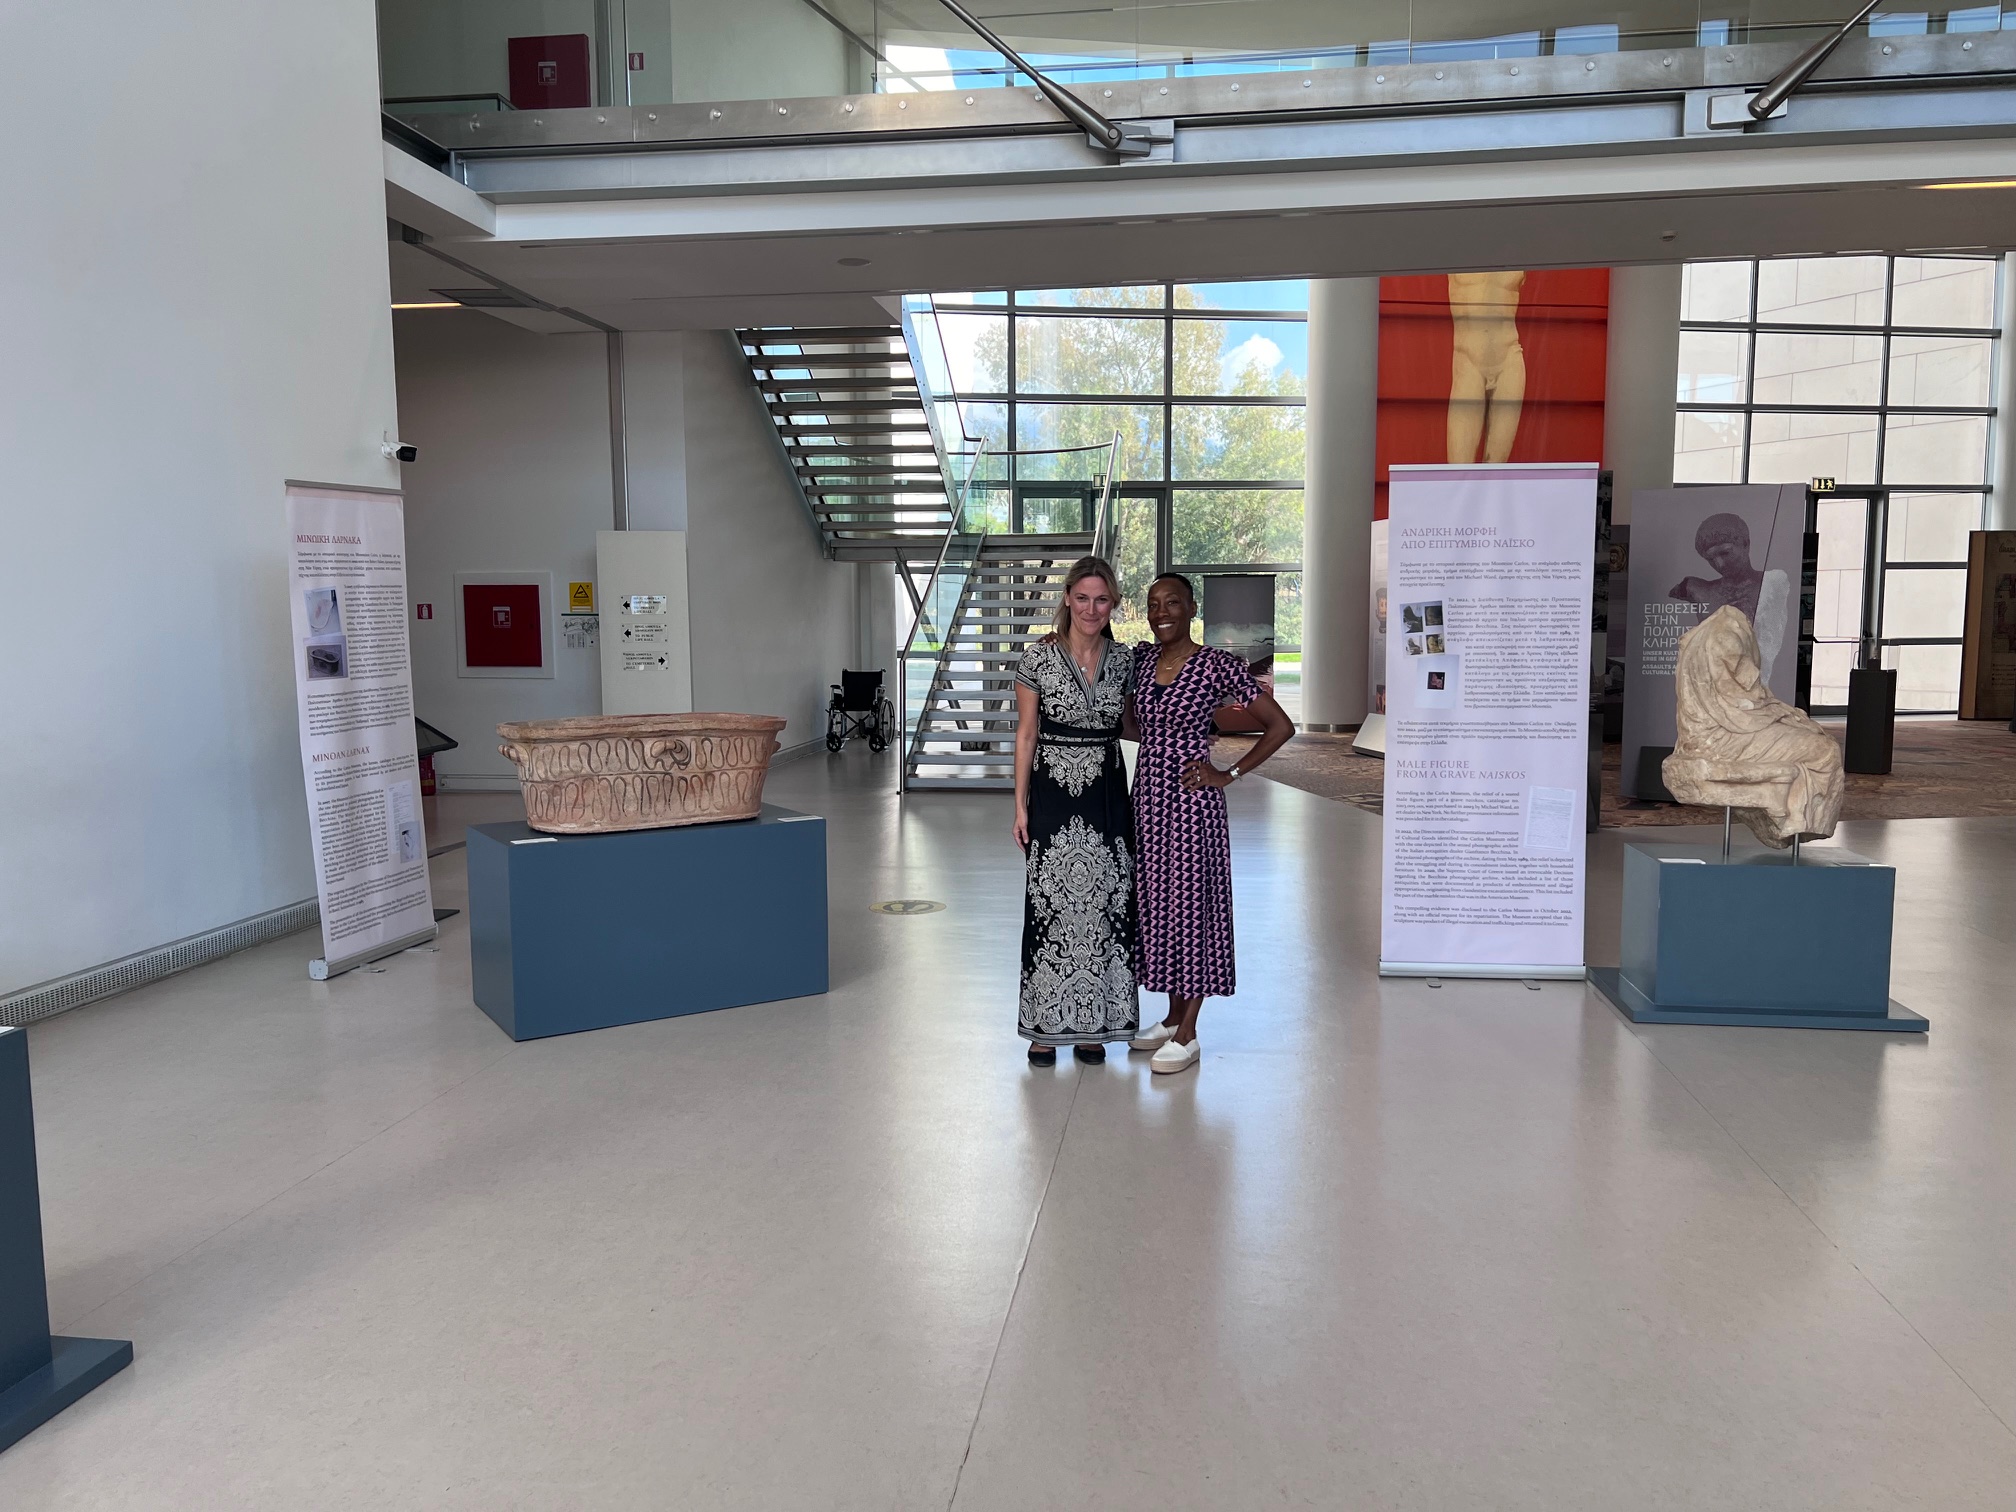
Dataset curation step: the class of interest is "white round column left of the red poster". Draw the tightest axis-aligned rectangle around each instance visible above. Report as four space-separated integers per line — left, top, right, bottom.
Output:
1302 278 1379 730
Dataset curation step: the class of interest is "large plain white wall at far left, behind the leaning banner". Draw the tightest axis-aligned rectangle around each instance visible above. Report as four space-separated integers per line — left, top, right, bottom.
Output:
0 0 397 1008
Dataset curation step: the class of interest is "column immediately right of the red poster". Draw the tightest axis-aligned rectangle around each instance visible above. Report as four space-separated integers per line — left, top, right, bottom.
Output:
1603 262 1679 524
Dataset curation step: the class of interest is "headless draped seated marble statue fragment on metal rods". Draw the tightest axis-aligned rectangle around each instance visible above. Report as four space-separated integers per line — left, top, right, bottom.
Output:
1661 603 1845 851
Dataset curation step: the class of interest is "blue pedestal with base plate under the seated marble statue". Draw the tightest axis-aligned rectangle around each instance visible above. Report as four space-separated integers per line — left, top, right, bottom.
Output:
1589 841 1925 1032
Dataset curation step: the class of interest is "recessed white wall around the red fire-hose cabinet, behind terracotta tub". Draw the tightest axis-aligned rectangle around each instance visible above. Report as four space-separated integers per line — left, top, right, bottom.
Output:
397 310 615 780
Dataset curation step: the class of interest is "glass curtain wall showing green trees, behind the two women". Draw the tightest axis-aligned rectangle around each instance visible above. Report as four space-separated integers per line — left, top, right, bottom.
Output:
935 282 1308 651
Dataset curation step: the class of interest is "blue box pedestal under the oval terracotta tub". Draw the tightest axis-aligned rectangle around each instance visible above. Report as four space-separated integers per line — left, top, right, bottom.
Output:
470 804 827 1040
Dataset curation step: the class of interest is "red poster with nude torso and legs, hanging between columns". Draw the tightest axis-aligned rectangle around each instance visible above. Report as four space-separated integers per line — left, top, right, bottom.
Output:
1373 268 1611 520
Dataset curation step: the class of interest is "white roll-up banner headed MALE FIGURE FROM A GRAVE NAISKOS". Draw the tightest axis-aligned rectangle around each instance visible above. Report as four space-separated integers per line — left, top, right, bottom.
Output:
1379 464 1597 978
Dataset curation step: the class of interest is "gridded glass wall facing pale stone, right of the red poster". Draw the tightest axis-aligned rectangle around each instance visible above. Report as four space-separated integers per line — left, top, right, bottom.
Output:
1673 256 2000 714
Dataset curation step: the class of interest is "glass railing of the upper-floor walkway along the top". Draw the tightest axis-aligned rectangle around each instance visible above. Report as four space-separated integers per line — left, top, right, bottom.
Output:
379 0 2016 117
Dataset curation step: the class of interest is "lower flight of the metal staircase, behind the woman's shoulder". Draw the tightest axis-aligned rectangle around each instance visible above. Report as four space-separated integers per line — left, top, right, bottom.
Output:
903 532 1093 790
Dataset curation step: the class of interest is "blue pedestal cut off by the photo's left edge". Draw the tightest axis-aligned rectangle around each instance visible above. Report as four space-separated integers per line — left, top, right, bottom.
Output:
0 1028 133 1450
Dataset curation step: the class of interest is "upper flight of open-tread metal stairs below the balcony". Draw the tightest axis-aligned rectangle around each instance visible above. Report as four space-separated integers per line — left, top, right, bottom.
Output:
736 325 952 562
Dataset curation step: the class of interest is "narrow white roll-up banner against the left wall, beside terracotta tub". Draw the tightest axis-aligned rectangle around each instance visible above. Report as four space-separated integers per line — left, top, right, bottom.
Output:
286 484 433 978
